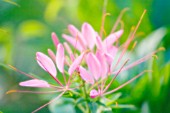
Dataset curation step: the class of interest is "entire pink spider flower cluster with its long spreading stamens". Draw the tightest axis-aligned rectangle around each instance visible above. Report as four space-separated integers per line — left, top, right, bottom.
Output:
8 9 163 112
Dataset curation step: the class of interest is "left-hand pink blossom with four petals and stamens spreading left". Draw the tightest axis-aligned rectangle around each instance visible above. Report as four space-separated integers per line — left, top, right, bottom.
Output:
7 43 87 113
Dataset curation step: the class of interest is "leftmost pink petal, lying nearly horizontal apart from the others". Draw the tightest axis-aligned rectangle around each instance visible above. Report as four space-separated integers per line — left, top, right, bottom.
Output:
19 79 50 88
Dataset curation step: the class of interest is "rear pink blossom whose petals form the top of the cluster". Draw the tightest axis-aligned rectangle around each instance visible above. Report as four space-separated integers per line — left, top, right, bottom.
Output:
62 23 123 64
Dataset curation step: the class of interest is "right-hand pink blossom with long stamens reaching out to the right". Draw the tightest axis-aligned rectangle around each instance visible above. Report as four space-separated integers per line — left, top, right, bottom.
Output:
74 11 160 98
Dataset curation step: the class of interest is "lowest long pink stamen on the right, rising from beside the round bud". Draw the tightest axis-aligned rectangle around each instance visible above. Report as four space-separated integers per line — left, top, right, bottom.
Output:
104 70 152 96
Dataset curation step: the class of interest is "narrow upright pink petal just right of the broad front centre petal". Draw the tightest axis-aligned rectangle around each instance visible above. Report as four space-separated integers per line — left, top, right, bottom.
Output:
96 51 109 78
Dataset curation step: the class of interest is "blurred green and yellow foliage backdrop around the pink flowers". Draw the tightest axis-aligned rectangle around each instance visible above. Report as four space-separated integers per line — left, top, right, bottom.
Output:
0 0 170 113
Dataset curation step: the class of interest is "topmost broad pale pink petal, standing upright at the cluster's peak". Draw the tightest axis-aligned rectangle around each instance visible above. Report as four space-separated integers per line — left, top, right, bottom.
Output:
82 23 96 49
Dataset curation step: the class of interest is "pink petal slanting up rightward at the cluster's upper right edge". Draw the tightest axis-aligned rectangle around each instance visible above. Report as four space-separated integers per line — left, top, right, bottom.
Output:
104 30 123 46
